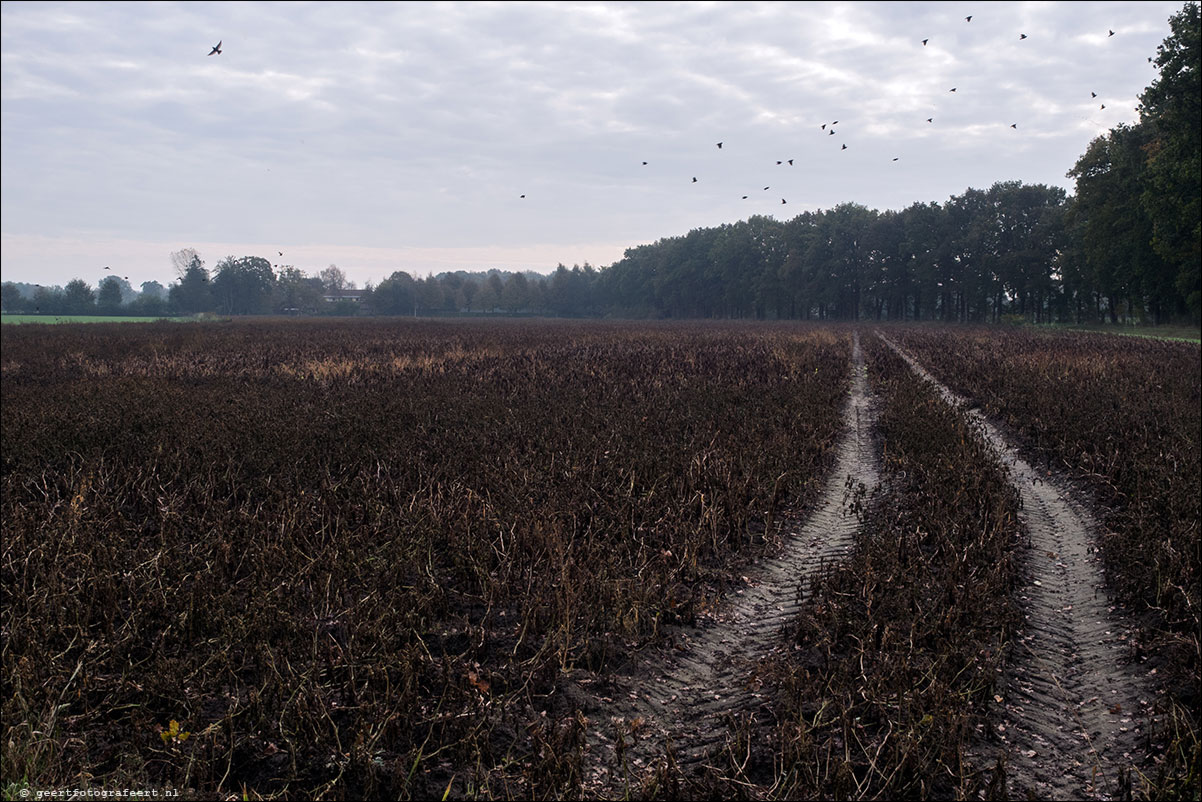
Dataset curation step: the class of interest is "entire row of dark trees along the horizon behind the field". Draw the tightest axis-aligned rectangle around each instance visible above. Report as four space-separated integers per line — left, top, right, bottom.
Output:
4 2 1202 322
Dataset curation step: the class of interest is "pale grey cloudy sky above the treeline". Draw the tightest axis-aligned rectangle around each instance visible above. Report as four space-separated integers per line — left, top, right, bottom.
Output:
0 0 1183 286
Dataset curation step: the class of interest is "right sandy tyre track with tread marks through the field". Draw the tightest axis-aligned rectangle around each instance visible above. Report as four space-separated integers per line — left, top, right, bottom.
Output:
879 334 1153 800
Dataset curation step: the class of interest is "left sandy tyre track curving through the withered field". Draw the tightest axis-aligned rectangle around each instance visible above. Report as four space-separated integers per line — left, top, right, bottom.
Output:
583 334 877 798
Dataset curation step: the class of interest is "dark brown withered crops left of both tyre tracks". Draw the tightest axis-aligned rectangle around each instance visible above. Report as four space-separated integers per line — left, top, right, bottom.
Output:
0 321 849 798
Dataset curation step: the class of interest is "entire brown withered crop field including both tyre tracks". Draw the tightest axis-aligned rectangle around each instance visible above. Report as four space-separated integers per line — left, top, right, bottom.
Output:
0 321 1202 800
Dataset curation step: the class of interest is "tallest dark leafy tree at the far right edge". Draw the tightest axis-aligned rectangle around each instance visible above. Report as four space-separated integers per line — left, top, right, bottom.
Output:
1139 2 1202 316
